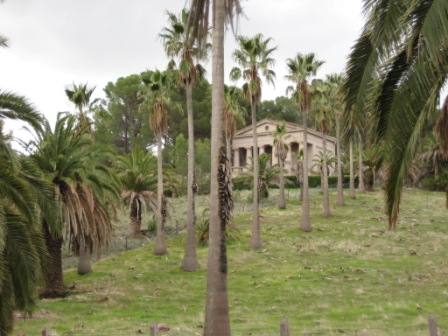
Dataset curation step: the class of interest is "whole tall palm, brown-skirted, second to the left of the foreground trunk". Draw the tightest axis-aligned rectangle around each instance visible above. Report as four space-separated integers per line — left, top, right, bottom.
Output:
140 70 178 255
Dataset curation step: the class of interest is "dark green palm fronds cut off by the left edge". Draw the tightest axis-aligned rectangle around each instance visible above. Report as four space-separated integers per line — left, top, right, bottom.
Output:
0 91 50 335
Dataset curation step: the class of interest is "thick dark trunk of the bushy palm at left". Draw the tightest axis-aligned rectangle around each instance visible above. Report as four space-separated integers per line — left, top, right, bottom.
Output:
42 222 67 297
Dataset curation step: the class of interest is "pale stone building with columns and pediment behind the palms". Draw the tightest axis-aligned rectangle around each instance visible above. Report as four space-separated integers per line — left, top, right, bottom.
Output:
232 119 336 176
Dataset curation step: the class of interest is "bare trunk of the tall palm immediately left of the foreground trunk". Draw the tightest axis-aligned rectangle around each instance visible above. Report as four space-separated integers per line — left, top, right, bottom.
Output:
182 85 198 272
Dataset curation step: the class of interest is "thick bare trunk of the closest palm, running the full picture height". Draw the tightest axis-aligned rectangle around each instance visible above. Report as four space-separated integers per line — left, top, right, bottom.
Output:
204 0 231 336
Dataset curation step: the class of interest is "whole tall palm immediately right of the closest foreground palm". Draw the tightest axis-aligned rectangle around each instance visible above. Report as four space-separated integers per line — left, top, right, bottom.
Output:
230 34 277 249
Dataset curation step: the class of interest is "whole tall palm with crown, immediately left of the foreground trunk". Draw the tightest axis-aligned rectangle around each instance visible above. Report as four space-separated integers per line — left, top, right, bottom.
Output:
159 9 207 272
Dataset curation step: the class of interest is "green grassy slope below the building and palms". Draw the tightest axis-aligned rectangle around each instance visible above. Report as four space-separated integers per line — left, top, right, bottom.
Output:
14 189 448 336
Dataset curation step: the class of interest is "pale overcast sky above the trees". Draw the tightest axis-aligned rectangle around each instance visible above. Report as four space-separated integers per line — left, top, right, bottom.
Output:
0 0 364 138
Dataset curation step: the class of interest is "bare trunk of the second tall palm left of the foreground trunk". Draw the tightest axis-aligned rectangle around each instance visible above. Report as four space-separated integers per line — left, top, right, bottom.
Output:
154 133 168 255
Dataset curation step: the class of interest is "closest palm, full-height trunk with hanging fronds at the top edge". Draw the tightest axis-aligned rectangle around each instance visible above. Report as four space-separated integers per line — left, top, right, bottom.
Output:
188 0 241 336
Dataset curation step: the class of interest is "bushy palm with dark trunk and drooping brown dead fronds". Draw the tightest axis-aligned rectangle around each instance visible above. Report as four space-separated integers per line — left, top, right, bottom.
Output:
31 114 118 296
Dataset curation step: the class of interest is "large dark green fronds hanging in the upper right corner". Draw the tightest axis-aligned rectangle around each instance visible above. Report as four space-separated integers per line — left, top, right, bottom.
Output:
344 0 448 230
